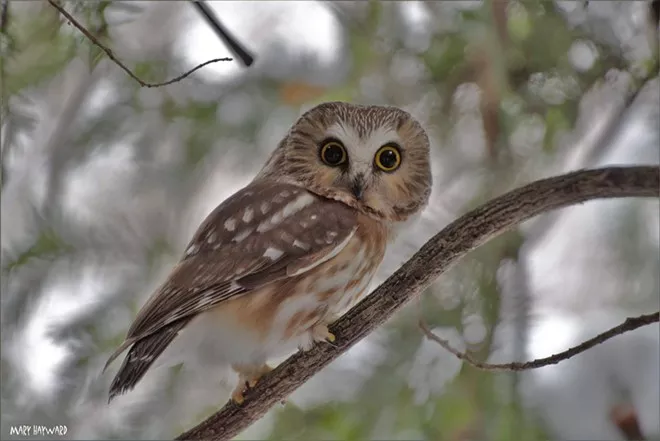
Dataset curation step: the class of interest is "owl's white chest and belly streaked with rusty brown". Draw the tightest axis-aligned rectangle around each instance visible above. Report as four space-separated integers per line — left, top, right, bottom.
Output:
210 215 389 358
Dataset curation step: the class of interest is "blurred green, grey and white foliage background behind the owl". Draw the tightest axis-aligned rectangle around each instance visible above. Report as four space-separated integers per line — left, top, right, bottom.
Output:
0 0 660 441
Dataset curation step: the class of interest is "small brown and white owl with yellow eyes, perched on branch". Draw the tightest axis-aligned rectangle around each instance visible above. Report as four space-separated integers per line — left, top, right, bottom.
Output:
106 102 432 404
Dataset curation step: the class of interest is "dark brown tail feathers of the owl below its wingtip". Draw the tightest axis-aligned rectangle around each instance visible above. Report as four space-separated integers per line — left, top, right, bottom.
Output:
108 317 190 403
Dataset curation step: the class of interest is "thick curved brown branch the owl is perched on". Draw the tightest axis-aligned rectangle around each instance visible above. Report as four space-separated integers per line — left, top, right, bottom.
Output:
177 166 660 440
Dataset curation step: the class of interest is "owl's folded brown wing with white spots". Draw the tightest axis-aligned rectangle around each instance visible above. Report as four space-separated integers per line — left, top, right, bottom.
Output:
106 182 357 367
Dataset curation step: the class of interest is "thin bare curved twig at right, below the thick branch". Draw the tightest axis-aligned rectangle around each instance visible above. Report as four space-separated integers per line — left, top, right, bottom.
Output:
419 311 660 371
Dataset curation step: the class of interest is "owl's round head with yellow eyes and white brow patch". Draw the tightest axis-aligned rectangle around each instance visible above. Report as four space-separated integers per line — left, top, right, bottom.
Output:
257 102 432 221
